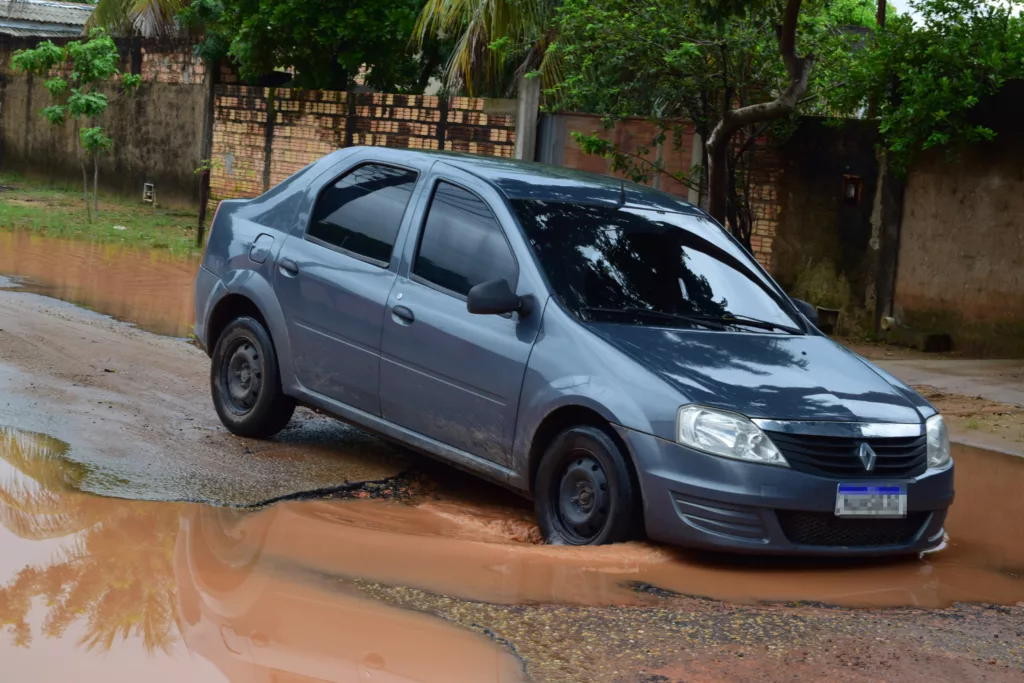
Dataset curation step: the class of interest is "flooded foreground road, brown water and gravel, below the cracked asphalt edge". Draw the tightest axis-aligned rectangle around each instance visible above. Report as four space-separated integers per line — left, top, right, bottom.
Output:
0 428 1024 683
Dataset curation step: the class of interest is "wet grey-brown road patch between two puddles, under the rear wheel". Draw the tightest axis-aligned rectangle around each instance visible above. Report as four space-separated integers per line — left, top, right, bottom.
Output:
0 274 408 505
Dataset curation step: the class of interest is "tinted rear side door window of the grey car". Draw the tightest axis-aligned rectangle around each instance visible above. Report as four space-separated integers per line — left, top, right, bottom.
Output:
306 164 417 266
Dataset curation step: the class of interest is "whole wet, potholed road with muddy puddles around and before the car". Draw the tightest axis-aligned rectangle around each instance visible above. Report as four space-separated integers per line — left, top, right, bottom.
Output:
0 236 1024 683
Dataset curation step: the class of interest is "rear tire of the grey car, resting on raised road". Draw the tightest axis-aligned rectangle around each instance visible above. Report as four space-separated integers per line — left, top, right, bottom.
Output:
210 317 295 438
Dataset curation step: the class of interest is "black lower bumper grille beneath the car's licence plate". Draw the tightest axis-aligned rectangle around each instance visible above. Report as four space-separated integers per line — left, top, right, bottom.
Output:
776 510 931 548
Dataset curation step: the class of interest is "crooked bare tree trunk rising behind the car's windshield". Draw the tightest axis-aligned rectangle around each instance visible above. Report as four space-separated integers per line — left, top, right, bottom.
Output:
708 0 813 224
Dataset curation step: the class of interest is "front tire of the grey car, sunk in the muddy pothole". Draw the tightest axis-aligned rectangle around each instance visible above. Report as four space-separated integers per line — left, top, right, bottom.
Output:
535 426 642 546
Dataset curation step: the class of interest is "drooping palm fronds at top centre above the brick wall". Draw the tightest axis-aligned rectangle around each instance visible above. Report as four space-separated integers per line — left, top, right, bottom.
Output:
413 0 561 95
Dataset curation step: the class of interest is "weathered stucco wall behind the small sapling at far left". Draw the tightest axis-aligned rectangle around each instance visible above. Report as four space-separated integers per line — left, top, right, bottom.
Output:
0 36 207 208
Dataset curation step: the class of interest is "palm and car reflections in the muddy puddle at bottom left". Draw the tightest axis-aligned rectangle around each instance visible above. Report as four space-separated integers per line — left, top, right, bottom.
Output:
0 428 524 683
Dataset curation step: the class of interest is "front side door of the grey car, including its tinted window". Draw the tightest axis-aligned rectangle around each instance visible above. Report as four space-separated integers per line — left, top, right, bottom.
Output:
381 172 540 465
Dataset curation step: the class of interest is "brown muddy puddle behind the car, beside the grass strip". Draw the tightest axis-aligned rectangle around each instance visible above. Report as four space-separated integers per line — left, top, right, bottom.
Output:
0 230 199 337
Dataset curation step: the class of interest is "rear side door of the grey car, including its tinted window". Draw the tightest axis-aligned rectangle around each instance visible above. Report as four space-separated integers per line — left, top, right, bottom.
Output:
274 161 419 415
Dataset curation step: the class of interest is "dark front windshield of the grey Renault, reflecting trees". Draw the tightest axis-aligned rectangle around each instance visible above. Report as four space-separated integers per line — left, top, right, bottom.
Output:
513 200 801 333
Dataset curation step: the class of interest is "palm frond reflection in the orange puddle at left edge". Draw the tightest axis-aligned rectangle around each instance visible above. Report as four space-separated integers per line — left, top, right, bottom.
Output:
0 428 178 652
